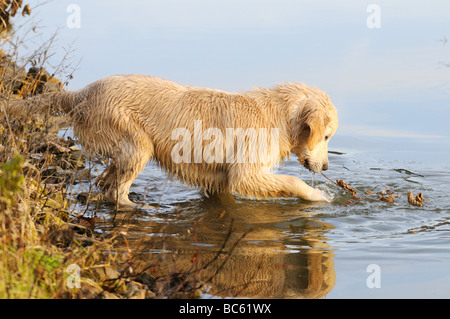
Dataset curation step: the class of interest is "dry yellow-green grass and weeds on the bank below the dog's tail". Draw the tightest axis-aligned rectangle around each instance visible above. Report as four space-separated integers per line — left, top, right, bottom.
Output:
0 78 132 298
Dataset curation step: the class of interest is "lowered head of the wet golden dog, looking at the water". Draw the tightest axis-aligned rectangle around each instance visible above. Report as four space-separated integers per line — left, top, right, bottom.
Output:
290 88 338 173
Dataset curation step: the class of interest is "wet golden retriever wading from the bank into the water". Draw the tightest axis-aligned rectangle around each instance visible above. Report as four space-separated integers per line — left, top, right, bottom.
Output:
6 75 338 207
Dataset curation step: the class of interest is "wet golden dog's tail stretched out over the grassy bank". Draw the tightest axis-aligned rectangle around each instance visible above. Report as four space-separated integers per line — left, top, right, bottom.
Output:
0 91 82 116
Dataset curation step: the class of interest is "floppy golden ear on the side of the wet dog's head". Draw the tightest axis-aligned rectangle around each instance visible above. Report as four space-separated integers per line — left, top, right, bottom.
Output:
301 107 329 151
